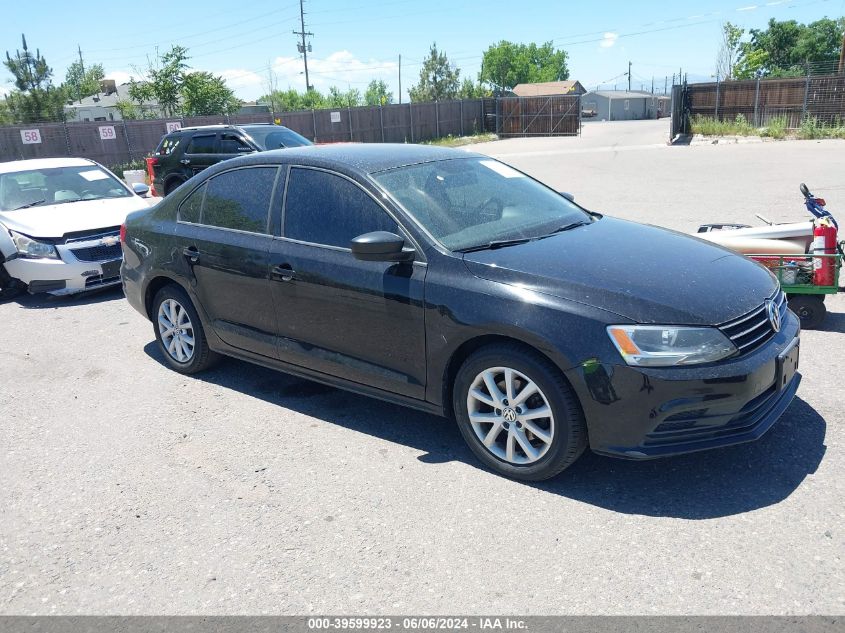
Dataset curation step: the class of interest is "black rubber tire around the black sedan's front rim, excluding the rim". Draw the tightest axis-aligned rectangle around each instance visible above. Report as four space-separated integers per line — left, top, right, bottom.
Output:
452 348 586 481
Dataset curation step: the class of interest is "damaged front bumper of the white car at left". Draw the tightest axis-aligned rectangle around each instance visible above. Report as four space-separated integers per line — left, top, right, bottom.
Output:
3 237 121 295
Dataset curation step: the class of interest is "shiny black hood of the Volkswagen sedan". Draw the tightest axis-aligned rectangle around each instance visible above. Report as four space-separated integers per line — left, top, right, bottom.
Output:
464 217 777 325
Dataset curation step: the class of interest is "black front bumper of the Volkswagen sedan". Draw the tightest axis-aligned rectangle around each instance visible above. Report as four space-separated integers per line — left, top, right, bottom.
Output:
567 311 801 459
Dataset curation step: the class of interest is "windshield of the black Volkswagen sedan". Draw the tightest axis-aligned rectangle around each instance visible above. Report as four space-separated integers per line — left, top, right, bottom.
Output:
372 157 591 251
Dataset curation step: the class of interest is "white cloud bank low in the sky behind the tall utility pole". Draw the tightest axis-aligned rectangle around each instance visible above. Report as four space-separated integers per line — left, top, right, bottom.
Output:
221 50 398 99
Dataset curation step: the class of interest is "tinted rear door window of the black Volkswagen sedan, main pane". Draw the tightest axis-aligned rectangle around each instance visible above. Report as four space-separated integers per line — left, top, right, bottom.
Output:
201 167 278 233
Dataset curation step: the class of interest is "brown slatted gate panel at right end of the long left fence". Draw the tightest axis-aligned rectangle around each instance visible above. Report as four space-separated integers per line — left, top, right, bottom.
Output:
496 95 581 136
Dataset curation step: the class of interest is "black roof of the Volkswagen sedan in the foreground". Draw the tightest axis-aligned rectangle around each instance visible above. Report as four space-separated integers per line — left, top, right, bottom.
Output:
226 143 481 174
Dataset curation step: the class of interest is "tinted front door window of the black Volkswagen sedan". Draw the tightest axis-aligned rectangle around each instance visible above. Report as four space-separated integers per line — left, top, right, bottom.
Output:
284 168 399 248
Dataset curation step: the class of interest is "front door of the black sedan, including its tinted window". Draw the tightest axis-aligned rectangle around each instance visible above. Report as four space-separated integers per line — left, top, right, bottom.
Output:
270 167 426 399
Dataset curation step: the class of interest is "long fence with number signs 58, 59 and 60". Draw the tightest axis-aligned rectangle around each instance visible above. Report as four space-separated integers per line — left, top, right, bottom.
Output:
0 99 495 166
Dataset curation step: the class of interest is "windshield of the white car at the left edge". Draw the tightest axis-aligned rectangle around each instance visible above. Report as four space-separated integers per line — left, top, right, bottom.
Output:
0 164 132 211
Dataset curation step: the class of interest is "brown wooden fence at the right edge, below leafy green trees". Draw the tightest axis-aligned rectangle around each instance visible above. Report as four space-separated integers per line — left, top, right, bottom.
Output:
684 75 845 129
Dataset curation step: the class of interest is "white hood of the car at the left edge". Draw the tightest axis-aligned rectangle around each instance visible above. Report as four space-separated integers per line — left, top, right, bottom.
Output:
0 196 148 239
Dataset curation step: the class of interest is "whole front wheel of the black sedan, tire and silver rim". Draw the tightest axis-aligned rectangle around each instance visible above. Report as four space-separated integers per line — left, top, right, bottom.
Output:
452 344 587 481
